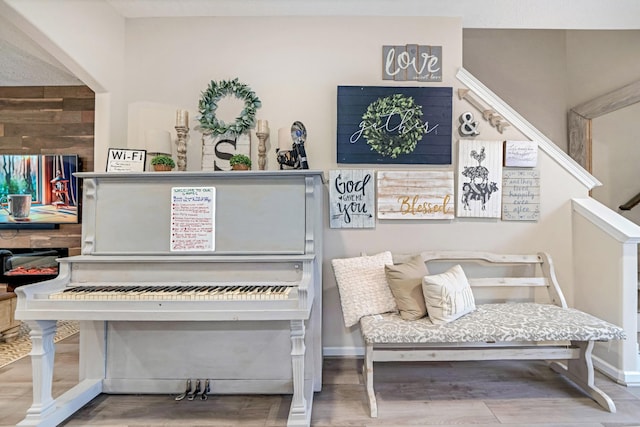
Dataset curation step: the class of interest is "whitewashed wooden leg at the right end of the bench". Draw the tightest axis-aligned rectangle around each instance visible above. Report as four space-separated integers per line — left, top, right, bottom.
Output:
550 341 616 413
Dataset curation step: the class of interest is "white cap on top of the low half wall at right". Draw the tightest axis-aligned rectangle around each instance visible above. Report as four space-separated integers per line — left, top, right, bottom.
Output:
571 198 640 244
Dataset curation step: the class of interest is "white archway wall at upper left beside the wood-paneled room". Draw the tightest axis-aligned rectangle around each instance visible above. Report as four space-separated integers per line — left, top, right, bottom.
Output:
0 0 127 170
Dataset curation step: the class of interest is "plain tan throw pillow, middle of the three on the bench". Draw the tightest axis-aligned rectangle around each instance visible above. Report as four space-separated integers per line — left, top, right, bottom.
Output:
384 255 429 320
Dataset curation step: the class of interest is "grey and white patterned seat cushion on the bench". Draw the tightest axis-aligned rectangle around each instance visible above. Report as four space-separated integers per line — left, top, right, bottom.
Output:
360 303 625 344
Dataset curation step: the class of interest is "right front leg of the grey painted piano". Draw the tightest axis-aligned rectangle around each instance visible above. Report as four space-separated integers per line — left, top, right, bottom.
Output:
287 320 313 427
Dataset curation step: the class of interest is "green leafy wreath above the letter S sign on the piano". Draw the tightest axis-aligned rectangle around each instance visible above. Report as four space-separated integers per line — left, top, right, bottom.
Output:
198 78 262 135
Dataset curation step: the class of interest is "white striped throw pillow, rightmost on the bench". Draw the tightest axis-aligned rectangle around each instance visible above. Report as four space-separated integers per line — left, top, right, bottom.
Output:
422 265 476 325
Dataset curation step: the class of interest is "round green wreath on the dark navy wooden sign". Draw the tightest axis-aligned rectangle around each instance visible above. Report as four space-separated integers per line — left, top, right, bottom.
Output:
361 93 426 159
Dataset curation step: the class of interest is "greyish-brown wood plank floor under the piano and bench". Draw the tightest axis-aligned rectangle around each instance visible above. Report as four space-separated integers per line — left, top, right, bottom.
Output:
0 335 640 427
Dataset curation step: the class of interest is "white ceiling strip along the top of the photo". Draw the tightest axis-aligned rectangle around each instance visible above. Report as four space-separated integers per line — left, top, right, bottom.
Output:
104 0 640 30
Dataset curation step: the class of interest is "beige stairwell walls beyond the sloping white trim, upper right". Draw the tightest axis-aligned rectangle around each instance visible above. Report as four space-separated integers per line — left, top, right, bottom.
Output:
463 29 640 229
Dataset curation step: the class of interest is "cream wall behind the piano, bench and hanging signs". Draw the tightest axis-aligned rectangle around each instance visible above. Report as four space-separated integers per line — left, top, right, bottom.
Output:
119 17 586 352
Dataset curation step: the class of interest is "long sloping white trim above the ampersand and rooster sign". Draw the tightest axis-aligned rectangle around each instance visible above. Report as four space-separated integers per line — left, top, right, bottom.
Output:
456 68 602 190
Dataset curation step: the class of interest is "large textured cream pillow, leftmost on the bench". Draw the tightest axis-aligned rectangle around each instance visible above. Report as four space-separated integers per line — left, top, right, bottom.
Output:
331 251 397 328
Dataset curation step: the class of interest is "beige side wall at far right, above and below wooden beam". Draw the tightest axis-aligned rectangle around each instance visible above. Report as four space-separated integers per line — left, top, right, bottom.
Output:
567 31 640 224
